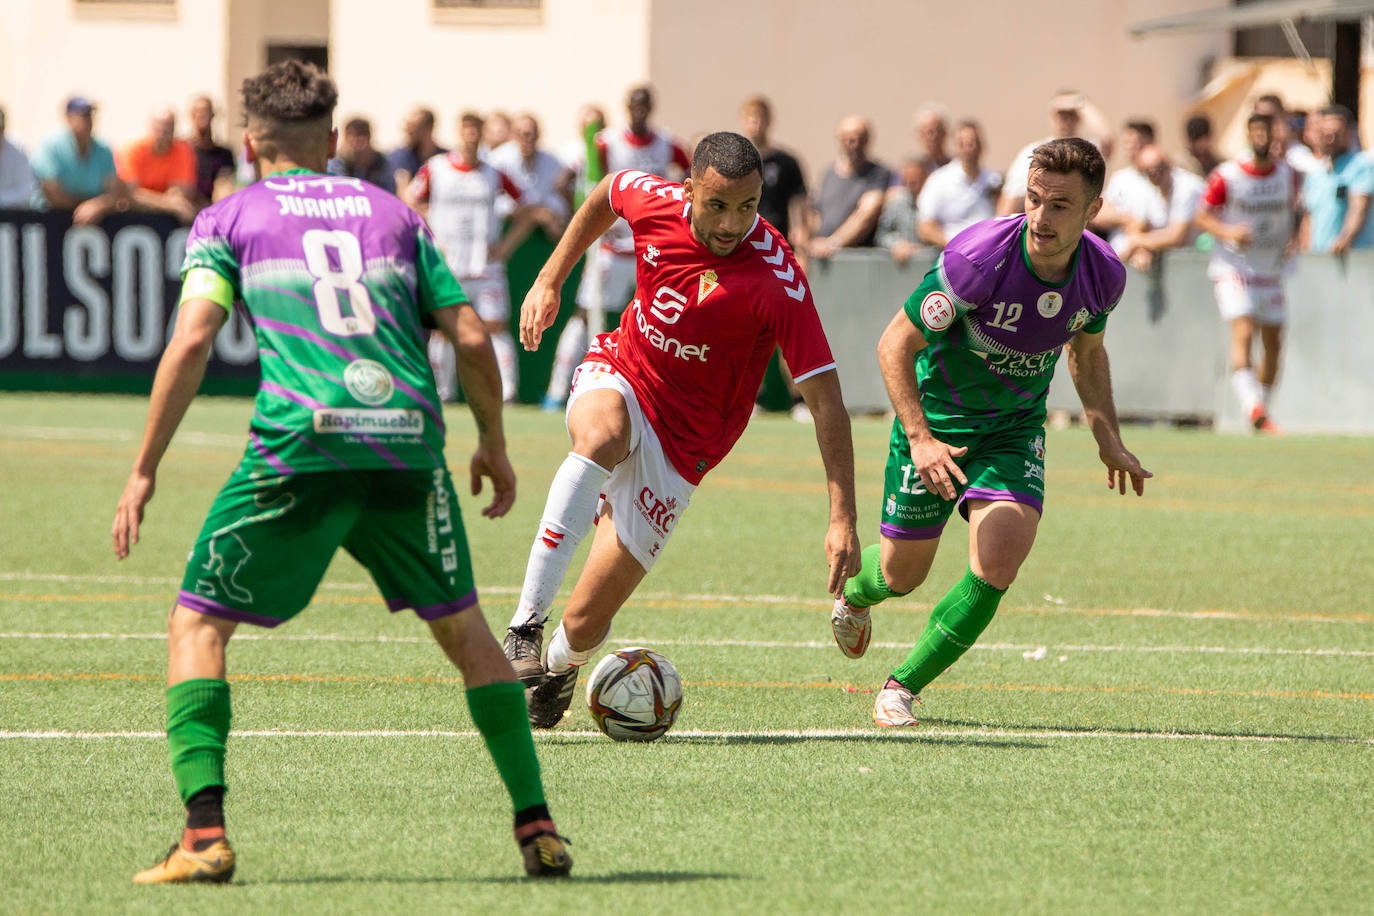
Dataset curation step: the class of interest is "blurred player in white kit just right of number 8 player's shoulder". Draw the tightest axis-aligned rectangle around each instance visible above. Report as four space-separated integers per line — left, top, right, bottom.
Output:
408 113 522 402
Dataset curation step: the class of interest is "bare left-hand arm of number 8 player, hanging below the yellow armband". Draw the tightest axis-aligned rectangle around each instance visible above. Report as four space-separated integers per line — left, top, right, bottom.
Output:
110 299 229 560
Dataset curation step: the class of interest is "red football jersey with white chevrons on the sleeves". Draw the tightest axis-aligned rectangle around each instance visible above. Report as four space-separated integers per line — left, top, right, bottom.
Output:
592 170 835 485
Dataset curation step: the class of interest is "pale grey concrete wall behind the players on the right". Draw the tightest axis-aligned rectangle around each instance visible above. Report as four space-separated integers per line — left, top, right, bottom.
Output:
809 251 1374 434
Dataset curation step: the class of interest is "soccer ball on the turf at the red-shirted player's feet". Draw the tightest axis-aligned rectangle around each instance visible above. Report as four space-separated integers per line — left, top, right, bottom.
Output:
587 647 683 742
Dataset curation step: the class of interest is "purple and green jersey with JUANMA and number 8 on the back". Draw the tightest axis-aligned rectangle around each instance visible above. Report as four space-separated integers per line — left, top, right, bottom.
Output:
181 169 467 475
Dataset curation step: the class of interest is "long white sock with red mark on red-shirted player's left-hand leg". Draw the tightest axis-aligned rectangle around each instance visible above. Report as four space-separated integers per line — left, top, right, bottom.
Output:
510 452 610 626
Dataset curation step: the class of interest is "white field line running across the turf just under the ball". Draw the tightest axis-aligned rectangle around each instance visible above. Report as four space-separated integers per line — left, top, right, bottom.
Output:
0 726 1374 744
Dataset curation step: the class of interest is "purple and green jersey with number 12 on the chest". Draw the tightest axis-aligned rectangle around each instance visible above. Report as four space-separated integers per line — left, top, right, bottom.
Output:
905 216 1125 433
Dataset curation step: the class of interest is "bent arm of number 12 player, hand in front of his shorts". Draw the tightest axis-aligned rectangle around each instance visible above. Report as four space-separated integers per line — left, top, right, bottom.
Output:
878 309 969 500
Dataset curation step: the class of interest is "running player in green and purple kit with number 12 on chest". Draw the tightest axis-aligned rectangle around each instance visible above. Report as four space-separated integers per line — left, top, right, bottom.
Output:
830 139 1151 725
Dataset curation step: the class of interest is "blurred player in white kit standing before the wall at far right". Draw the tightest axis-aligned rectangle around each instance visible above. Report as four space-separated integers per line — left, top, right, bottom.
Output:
1195 114 1300 434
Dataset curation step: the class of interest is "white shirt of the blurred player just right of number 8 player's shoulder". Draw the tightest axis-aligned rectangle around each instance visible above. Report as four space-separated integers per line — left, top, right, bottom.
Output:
411 152 521 279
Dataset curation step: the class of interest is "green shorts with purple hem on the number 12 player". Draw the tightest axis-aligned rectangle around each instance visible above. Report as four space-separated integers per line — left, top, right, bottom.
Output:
878 422 1044 541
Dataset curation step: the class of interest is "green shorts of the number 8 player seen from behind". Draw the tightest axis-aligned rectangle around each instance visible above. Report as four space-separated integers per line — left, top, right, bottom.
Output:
177 468 477 626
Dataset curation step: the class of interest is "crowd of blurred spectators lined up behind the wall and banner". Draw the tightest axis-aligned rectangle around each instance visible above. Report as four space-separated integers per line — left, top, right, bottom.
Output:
0 85 1374 271
